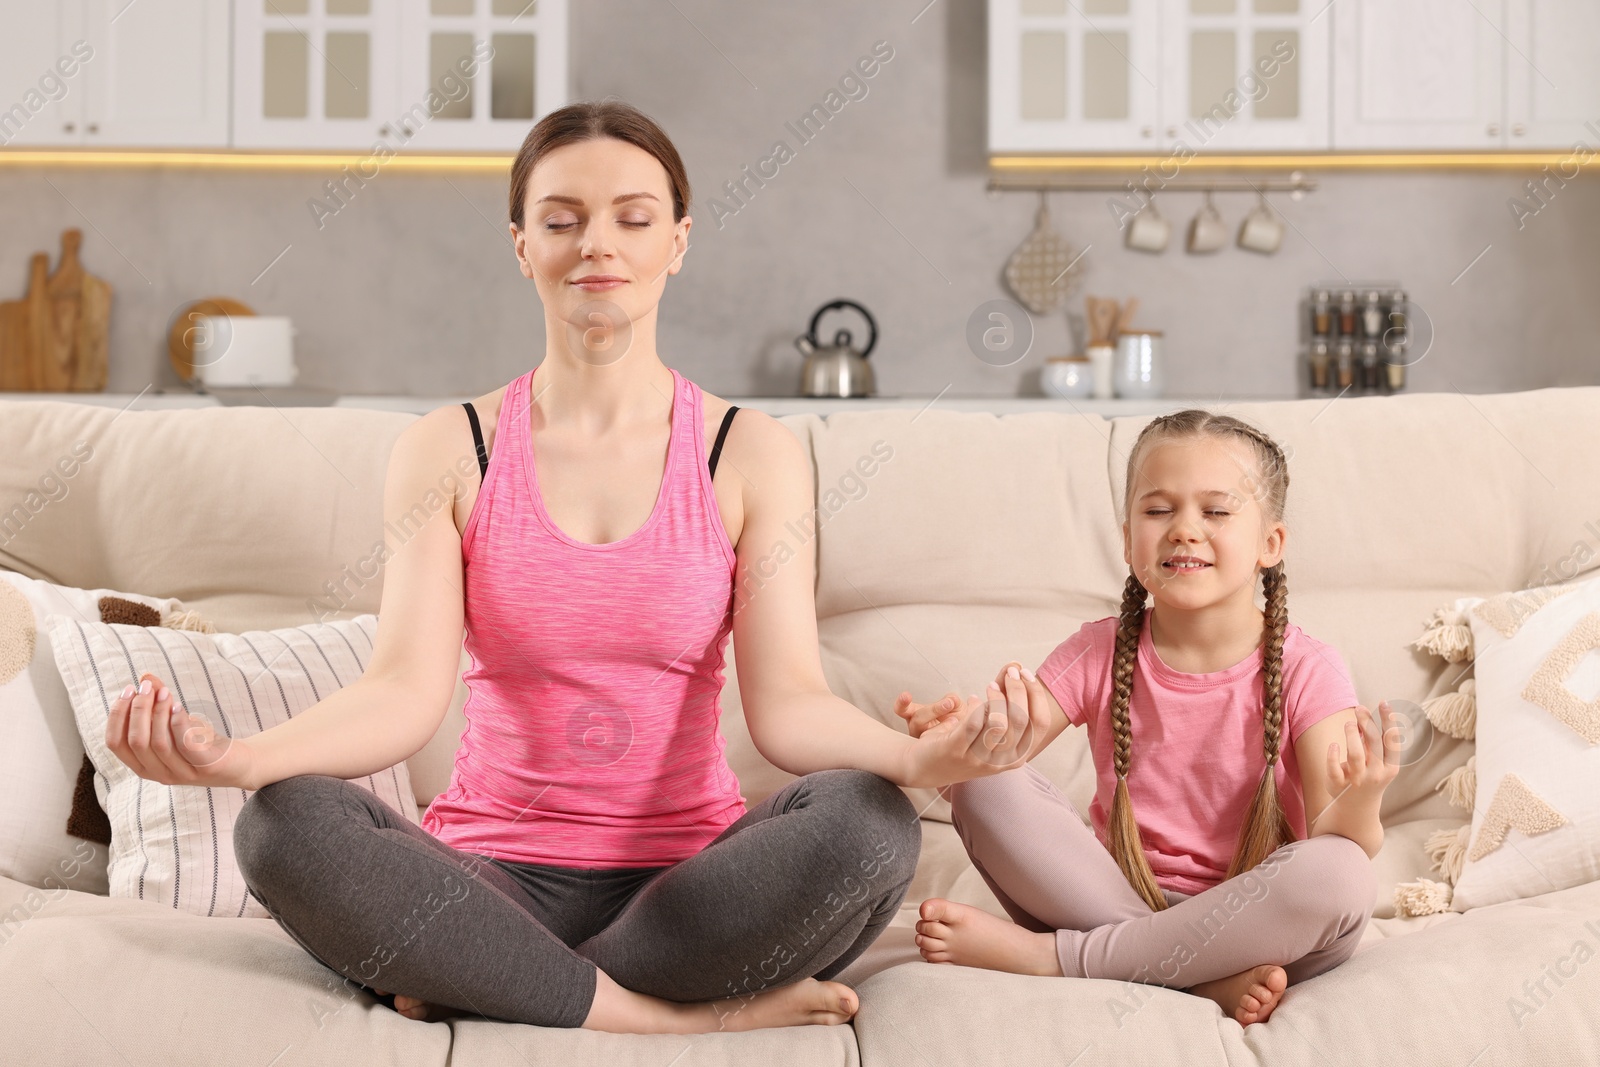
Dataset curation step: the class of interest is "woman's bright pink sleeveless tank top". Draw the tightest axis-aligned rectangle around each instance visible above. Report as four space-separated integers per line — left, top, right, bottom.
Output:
422 370 744 867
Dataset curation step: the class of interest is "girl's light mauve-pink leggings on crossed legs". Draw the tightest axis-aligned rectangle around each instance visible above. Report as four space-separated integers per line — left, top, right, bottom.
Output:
946 765 1376 989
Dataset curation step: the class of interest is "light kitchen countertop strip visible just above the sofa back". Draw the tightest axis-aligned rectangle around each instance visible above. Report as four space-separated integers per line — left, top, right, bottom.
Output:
0 389 1254 418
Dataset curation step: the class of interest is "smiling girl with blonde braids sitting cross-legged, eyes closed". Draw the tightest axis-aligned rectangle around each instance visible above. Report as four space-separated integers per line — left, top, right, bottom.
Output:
896 410 1400 1025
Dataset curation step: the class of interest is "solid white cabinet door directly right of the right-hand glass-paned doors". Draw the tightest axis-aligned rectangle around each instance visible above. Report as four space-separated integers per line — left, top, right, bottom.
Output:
1333 0 1504 150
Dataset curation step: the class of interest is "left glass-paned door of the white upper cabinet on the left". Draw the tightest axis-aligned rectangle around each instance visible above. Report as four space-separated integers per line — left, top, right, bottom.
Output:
234 0 398 149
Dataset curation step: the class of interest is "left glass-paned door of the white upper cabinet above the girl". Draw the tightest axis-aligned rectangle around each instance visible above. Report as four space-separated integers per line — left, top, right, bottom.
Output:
989 0 1162 152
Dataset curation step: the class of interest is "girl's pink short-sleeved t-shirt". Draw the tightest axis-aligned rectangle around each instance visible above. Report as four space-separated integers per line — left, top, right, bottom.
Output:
1035 609 1357 894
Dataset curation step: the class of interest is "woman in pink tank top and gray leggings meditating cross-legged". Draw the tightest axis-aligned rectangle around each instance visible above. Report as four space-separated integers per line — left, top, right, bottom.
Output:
107 102 1045 1033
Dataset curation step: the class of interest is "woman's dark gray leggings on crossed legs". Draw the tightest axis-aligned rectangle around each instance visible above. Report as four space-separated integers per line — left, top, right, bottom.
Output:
234 769 922 1027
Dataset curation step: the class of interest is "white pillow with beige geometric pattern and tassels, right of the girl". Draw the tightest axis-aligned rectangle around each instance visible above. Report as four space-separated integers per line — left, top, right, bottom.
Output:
1451 581 1600 912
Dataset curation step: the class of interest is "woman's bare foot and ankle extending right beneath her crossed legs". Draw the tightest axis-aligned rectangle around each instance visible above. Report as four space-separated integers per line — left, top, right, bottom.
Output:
584 971 861 1033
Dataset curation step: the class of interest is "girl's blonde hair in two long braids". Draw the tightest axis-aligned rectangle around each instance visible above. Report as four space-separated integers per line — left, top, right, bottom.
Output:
1106 408 1294 912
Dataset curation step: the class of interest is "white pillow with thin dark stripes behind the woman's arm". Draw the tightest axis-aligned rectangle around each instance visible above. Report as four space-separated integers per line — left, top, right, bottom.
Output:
48 614 418 918
